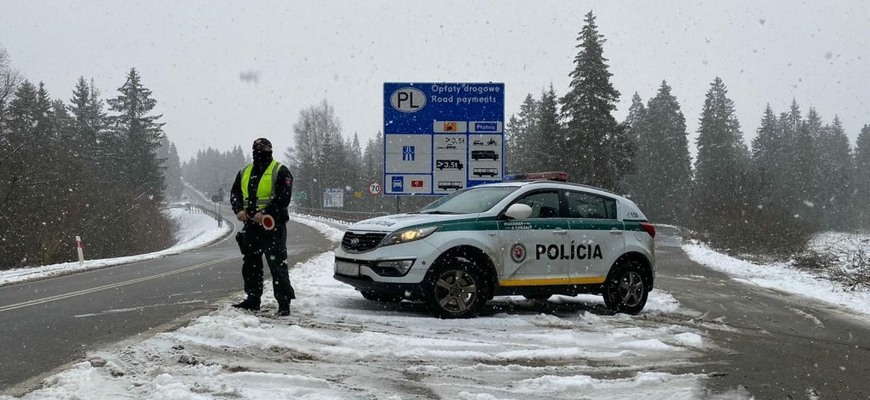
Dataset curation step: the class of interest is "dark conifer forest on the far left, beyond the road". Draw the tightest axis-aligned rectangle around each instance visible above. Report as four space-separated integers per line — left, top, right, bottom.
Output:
0 48 181 268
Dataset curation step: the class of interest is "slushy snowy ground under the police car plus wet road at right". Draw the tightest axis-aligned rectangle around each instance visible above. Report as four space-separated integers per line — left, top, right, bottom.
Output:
0 219 870 400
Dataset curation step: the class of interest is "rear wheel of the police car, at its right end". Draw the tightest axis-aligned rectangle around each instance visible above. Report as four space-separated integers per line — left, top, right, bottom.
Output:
603 260 649 315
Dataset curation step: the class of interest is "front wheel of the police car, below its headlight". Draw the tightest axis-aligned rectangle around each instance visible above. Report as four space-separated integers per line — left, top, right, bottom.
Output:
426 258 488 318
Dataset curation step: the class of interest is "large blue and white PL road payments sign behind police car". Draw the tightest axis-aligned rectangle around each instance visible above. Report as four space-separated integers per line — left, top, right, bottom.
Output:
383 83 504 195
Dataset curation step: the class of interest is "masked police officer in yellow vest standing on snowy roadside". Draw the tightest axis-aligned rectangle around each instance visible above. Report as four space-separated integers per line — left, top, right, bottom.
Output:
230 138 296 316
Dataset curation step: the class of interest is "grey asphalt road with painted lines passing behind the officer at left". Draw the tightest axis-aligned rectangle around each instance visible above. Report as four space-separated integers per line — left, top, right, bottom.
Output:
0 216 333 395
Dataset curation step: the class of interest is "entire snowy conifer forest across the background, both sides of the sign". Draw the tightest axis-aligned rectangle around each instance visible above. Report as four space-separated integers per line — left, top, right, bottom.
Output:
0 12 870 267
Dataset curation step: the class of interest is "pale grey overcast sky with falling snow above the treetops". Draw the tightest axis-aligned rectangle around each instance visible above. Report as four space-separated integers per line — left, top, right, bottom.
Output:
0 0 870 160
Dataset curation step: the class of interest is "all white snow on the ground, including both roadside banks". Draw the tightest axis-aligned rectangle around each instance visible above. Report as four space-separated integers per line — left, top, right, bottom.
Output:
0 213 870 400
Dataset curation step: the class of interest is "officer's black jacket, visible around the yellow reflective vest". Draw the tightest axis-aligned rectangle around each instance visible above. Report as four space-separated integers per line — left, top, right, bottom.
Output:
230 160 293 224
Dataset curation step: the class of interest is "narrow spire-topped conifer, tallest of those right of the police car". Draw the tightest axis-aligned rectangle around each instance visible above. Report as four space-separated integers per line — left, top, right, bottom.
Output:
692 77 749 247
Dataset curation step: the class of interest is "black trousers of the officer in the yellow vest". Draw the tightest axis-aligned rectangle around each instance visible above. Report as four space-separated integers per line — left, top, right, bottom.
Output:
239 224 296 307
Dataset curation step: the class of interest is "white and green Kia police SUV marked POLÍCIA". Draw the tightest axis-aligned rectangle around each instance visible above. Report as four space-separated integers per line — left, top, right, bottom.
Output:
334 181 655 318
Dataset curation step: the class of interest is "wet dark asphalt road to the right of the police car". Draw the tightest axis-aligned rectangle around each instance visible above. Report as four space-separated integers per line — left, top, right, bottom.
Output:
656 228 870 399
